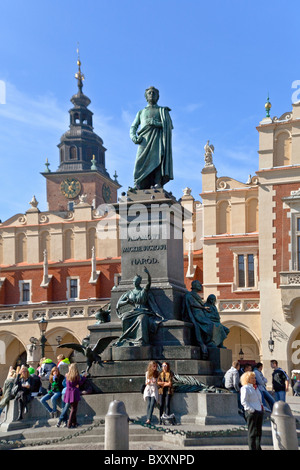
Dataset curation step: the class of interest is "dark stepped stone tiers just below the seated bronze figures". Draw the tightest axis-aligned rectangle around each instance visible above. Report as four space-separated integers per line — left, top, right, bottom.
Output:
74 345 232 394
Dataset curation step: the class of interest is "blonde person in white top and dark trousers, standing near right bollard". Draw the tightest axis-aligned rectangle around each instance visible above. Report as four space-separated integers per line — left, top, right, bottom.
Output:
241 372 264 450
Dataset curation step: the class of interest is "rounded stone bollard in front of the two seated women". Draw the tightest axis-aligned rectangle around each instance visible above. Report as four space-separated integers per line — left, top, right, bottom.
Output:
104 400 129 450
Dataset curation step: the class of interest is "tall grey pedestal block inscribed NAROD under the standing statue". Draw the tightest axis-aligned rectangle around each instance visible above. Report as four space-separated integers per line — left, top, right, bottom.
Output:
111 188 191 321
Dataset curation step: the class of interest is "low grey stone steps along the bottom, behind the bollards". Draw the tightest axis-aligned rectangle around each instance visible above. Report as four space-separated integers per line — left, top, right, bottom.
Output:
0 420 300 450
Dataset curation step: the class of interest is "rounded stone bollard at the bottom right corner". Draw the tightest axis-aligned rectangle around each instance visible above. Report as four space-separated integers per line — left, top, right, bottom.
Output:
271 401 298 450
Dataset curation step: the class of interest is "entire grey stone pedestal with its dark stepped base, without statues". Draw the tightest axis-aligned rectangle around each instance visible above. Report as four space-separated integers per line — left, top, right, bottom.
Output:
82 189 232 408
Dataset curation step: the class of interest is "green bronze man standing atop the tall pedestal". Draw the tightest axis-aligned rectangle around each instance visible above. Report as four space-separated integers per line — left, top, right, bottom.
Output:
130 87 173 189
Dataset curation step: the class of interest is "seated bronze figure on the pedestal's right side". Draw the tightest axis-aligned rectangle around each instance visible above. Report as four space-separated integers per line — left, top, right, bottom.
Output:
184 280 229 359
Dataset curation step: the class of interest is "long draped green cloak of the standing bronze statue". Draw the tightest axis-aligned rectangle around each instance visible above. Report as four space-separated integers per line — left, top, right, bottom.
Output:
130 106 173 186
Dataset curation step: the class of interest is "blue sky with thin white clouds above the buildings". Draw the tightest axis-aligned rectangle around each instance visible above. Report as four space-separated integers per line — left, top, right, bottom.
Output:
0 0 300 221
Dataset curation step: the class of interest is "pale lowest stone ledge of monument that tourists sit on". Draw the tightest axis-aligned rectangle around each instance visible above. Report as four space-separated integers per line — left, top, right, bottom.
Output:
0 393 245 432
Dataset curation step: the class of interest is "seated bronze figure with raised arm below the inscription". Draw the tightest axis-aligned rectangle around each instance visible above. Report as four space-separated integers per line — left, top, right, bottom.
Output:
114 267 164 346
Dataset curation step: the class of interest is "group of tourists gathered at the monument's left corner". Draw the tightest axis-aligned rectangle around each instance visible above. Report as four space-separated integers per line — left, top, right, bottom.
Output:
0 355 86 428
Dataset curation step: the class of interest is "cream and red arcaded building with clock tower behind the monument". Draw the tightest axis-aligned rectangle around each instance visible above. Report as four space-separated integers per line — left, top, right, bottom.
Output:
0 62 300 383
